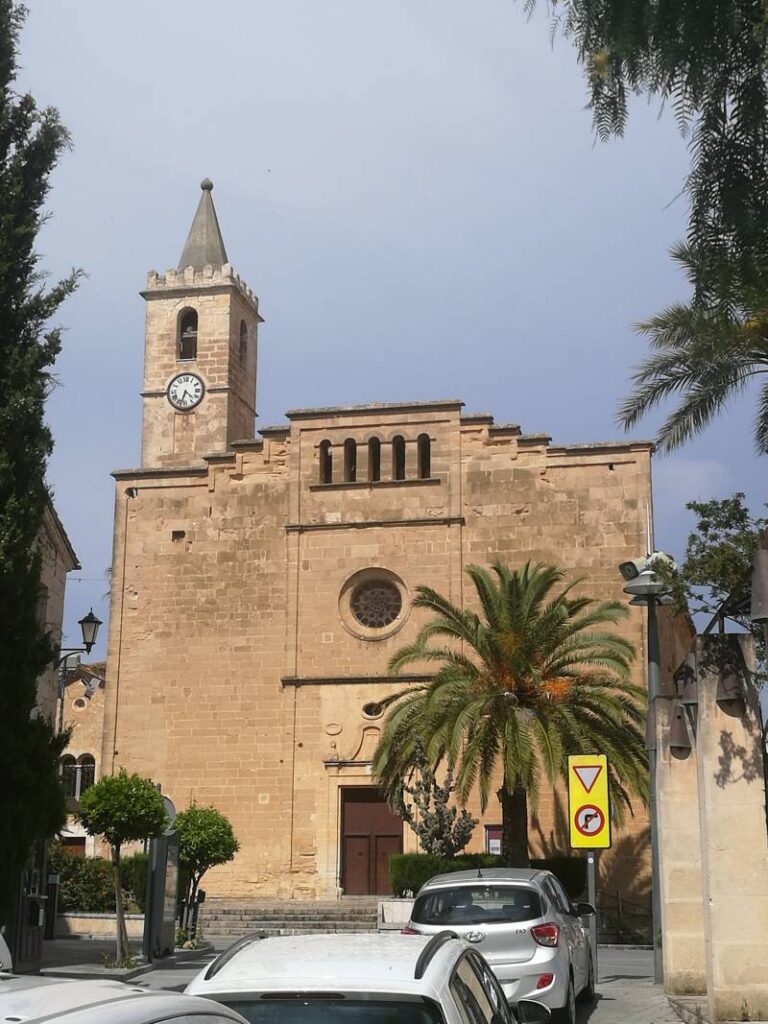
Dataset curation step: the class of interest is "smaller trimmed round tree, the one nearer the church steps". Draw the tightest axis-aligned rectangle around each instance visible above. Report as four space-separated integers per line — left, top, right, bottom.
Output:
174 804 240 938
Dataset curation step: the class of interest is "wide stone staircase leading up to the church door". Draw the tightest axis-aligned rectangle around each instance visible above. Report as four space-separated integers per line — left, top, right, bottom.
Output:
200 896 379 941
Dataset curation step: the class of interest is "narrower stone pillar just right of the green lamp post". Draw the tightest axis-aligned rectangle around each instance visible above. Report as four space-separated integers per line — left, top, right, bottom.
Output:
656 698 707 995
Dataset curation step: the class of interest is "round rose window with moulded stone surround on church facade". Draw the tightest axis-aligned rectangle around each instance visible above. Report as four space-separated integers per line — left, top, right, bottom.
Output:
339 568 408 640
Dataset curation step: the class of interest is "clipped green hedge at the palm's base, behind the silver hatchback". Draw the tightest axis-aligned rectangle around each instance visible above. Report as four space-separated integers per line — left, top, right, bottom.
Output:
389 853 587 900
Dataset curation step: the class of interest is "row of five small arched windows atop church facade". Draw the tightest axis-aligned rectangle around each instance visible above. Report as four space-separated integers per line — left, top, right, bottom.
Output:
318 434 432 483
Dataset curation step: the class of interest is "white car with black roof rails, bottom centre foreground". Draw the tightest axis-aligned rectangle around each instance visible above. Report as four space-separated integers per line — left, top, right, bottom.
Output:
186 932 549 1024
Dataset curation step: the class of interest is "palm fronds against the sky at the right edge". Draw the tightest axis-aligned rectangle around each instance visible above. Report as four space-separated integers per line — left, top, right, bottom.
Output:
618 245 768 455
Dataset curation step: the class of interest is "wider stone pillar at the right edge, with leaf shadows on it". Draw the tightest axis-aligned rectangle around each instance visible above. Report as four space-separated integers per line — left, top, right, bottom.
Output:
696 634 768 1021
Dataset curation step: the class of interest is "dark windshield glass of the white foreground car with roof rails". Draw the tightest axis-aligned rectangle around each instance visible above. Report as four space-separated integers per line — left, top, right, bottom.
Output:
221 992 444 1024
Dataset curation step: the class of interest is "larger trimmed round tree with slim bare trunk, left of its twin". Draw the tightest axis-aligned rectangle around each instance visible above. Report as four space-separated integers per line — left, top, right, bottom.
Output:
79 768 168 966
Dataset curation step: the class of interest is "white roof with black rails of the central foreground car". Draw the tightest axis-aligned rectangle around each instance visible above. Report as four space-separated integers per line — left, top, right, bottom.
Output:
186 932 465 998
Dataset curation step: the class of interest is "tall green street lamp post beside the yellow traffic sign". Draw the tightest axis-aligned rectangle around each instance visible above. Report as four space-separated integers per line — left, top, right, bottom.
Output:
618 551 675 984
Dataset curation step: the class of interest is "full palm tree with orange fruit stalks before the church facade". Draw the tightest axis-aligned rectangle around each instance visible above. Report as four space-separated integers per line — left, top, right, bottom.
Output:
374 563 648 866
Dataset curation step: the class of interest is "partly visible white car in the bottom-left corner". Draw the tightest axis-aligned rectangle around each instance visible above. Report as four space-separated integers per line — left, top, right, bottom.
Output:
0 974 245 1024
